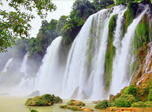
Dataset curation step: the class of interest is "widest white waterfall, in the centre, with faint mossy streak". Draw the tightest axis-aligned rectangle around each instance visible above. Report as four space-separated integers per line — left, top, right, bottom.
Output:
62 6 127 99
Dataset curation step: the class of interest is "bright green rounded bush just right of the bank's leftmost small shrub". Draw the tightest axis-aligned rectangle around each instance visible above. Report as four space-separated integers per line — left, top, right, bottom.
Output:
114 95 135 107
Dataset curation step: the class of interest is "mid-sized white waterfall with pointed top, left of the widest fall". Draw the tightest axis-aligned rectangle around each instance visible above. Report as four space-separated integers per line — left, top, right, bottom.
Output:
34 37 63 95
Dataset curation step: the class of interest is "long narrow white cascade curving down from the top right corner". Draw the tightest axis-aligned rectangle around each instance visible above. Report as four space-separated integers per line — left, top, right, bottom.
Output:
110 6 148 95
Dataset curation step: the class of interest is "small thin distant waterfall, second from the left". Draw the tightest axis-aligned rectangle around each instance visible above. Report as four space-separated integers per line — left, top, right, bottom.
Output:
20 52 28 76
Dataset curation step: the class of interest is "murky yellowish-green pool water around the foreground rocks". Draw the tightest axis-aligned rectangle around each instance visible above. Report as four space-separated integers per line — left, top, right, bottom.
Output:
0 96 106 112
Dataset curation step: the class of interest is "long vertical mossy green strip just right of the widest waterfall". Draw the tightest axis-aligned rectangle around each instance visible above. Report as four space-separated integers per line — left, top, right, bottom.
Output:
105 14 117 89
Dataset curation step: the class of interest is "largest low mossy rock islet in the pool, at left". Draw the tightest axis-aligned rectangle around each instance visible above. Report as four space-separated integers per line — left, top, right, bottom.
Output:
25 94 62 106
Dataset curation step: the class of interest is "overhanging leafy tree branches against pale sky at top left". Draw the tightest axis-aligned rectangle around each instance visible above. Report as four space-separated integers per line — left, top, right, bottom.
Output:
0 0 56 52
